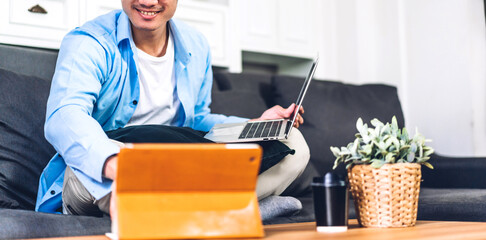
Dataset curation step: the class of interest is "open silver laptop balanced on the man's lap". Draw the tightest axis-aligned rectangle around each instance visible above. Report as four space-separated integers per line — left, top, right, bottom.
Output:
204 56 319 143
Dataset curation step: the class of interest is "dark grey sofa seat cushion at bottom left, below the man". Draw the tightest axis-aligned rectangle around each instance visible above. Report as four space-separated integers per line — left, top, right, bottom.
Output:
0 209 111 239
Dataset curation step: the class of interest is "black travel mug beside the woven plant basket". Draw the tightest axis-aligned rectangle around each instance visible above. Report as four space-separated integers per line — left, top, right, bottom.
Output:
312 172 348 232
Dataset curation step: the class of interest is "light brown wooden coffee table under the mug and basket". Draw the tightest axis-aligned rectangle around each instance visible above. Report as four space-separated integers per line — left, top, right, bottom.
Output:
32 219 486 240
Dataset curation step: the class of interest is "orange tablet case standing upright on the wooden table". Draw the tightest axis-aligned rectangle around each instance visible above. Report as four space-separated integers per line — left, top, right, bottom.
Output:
112 144 264 239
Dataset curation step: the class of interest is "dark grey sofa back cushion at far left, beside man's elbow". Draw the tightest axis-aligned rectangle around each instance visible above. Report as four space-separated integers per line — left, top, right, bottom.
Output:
0 69 55 209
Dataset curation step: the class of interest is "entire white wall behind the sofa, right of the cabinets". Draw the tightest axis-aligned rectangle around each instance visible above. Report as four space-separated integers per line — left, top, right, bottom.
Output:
320 0 486 156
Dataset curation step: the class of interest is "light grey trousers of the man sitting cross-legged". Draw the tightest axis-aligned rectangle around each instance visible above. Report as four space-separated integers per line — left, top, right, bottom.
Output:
62 129 310 216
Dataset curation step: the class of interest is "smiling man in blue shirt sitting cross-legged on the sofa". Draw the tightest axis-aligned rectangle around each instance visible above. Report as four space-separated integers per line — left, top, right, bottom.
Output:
36 0 309 216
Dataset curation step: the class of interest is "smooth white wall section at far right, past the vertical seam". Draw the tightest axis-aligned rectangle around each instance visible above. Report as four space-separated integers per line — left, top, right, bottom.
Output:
404 0 486 155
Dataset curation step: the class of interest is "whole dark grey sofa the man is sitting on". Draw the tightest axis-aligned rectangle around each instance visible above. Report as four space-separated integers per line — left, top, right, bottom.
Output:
0 44 486 239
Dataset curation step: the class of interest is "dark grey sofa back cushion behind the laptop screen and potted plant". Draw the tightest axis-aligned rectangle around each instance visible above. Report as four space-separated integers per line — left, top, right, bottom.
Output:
272 76 404 194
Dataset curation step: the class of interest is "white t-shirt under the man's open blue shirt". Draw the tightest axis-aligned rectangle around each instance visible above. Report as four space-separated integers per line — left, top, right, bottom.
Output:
126 31 181 126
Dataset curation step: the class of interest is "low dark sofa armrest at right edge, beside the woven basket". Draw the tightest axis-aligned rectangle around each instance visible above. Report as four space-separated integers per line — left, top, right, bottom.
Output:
421 154 486 189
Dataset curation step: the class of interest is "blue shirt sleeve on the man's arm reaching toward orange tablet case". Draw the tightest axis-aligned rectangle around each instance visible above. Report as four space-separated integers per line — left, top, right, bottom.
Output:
45 33 119 182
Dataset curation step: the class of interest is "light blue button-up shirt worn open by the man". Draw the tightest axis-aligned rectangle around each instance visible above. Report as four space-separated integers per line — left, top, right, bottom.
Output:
36 10 246 212
